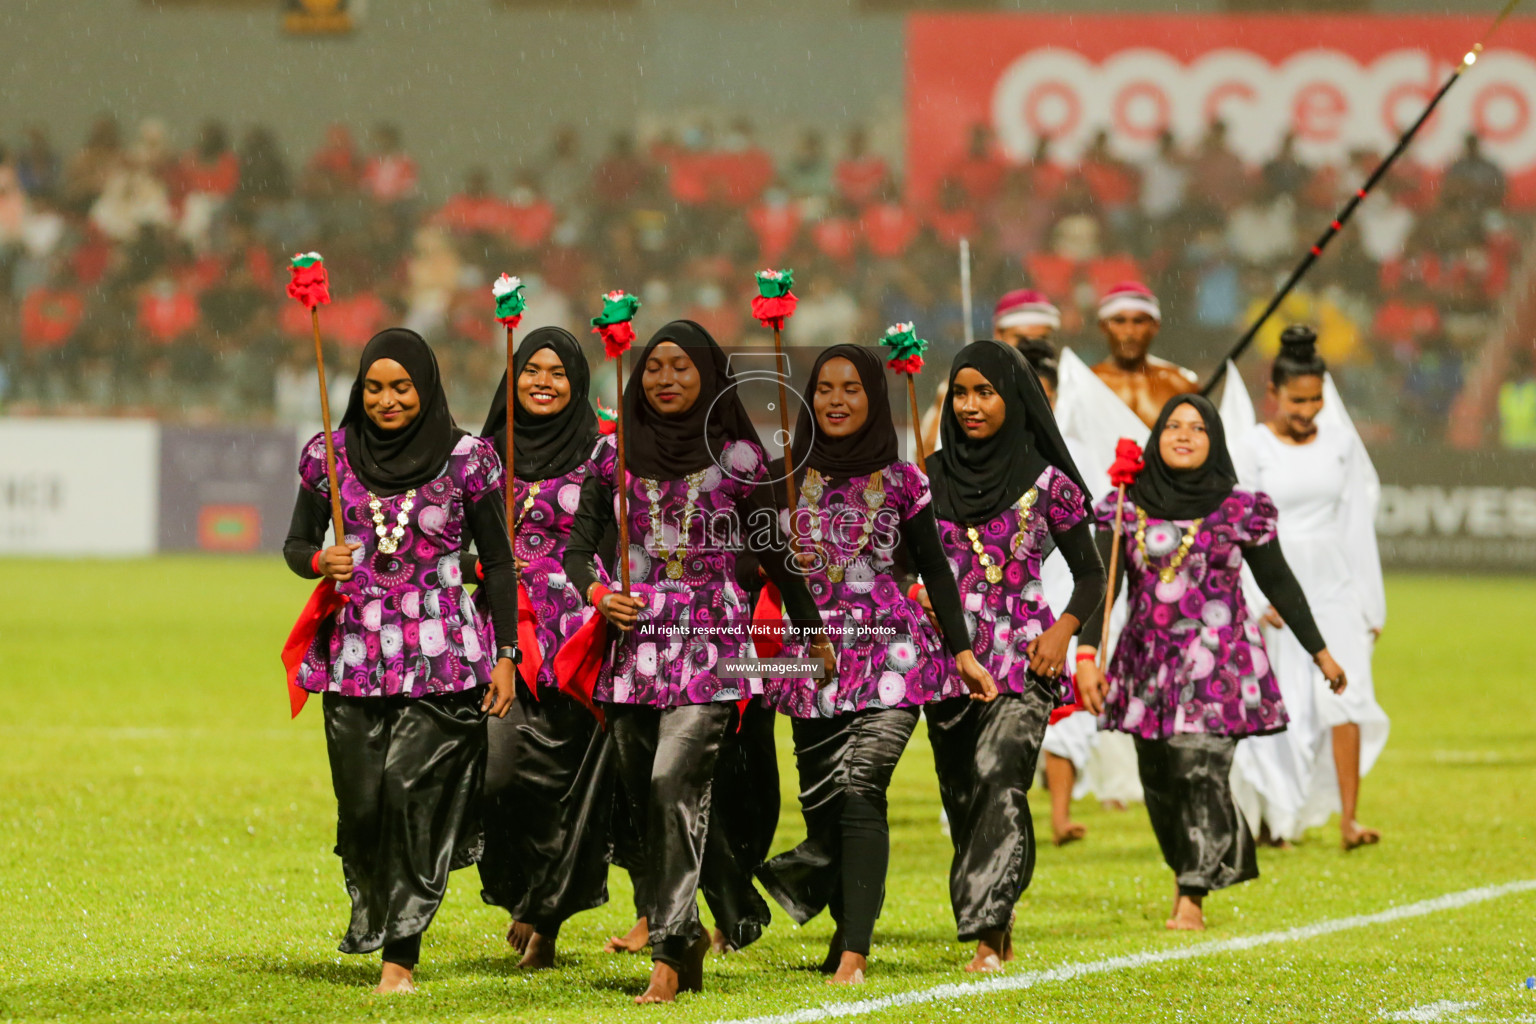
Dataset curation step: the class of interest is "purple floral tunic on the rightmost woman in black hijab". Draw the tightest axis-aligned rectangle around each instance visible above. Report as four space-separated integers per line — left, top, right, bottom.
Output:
1094 490 1287 740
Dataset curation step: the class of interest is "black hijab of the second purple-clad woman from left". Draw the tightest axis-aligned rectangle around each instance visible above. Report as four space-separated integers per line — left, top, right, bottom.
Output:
481 327 598 481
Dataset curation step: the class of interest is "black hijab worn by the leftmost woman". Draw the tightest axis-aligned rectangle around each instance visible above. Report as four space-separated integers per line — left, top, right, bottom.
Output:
341 327 464 497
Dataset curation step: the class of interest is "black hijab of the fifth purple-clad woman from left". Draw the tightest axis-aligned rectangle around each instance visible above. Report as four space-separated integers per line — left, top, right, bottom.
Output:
928 341 1091 527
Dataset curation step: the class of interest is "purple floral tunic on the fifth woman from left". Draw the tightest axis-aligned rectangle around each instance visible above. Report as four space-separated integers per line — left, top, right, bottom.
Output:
938 465 1087 703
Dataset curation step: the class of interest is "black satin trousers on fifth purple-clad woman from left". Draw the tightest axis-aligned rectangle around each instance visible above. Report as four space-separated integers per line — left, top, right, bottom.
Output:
923 686 1055 943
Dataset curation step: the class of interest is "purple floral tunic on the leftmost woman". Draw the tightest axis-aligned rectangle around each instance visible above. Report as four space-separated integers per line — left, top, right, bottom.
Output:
296 431 502 697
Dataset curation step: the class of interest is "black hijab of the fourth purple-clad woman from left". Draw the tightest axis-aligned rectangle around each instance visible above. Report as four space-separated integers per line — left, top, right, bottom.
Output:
794 345 900 479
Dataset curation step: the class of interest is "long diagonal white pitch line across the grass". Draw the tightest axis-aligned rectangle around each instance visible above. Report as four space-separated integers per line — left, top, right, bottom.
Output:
717 878 1536 1024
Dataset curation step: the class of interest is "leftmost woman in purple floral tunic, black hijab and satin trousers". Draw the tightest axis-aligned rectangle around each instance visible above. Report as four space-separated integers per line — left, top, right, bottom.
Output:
283 329 518 992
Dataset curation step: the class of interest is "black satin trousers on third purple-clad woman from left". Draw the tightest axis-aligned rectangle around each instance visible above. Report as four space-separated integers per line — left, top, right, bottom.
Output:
605 703 736 967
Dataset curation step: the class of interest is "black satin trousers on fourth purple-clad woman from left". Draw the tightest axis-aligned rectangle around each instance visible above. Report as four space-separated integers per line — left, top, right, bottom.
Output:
757 708 919 956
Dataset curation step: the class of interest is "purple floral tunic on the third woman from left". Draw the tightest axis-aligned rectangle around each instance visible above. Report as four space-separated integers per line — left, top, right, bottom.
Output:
593 438 766 708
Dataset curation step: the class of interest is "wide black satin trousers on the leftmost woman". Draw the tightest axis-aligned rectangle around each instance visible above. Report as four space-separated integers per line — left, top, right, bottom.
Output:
324 688 485 953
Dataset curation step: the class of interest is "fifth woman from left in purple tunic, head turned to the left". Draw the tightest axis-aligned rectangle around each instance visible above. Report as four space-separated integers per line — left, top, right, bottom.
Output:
920 341 1104 972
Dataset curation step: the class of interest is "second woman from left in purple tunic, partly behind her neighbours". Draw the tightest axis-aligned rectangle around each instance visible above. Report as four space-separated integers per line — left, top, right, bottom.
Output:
465 327 613 967
